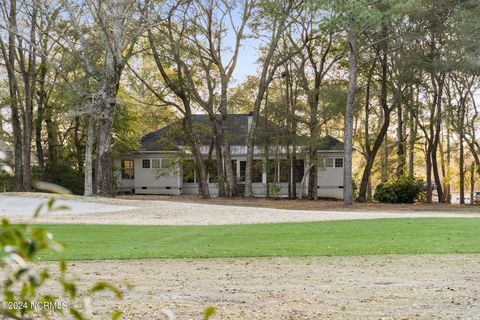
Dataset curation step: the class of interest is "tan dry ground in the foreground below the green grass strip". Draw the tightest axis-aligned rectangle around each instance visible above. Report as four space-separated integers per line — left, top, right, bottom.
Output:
29 255 480 319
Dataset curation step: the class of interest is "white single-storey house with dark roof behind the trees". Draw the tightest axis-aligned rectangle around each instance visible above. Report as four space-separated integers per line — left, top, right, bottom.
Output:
116 114 343 199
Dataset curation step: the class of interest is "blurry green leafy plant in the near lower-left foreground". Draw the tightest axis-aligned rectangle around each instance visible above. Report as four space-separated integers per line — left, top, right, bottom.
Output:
0 151 122 320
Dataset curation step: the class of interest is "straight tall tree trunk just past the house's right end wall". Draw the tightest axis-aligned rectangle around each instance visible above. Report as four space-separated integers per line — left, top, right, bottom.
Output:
343 27 358 206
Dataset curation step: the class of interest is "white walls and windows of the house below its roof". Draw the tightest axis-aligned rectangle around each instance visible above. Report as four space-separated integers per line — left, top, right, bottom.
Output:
117 153 343 199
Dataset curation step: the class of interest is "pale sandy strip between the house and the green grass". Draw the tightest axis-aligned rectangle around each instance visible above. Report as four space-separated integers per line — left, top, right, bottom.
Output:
0 192 480 225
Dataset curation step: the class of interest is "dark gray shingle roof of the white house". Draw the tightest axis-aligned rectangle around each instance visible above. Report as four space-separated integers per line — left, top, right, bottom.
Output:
140 114 343 151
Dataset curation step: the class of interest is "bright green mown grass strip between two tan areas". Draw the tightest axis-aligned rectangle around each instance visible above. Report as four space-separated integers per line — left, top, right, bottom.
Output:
36 218 480 260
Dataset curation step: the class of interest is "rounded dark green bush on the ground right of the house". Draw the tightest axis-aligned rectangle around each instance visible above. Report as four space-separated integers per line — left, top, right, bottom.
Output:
373 176 424 203
